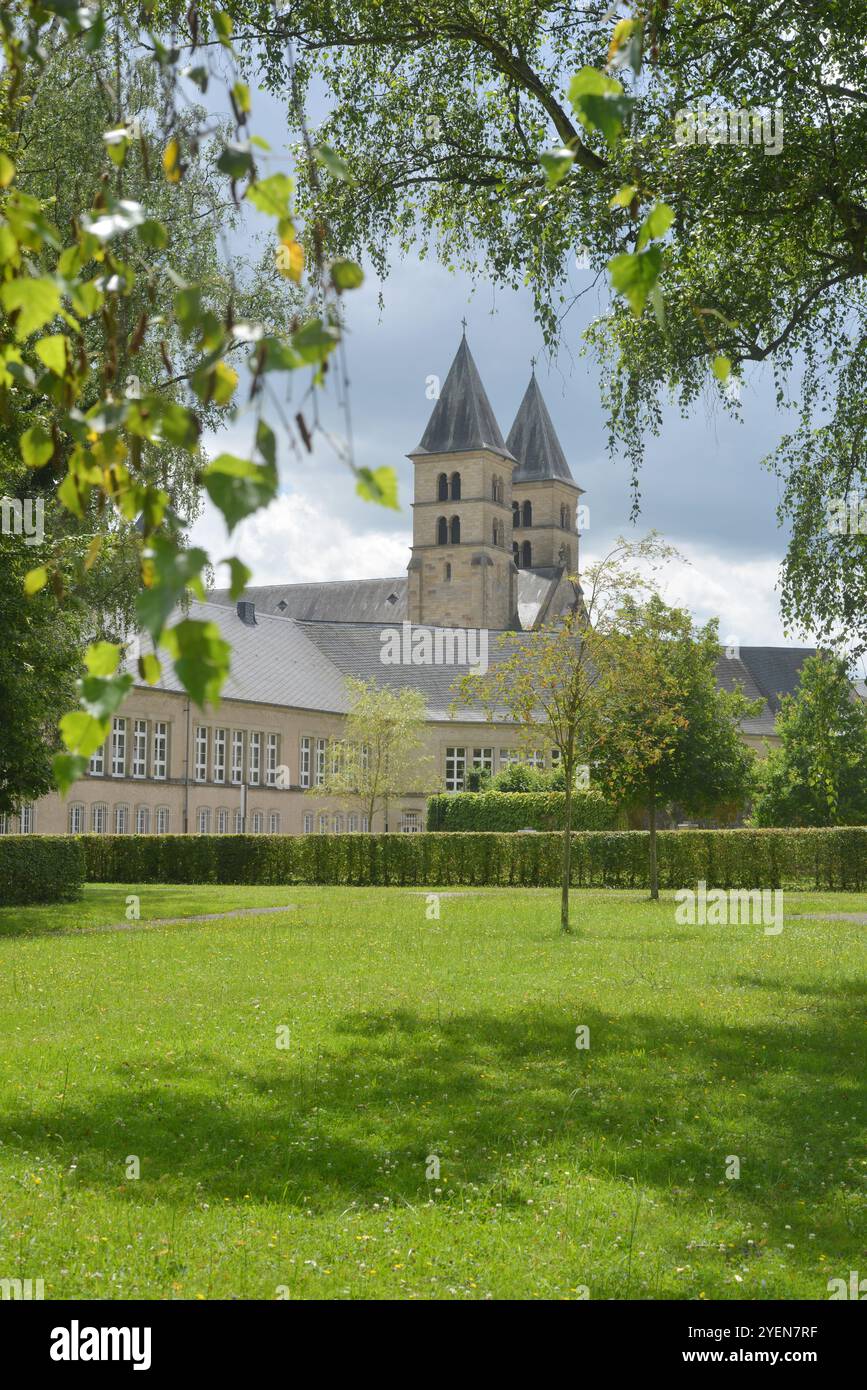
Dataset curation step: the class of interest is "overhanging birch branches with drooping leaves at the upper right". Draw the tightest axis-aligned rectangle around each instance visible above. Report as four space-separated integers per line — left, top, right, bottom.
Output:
232 0 867 645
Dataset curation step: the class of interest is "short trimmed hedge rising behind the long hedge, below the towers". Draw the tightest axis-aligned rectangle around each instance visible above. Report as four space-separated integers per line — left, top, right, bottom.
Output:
428 791 617 830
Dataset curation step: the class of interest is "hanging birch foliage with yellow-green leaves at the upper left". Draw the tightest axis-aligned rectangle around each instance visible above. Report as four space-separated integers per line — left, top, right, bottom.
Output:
0 0 383 790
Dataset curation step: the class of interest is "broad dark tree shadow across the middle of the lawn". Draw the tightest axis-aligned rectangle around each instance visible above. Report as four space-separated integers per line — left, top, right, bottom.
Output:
3 981 864 1244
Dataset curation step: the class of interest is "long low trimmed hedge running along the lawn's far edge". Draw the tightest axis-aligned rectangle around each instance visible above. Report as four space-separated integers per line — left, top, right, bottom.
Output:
83 827 867 891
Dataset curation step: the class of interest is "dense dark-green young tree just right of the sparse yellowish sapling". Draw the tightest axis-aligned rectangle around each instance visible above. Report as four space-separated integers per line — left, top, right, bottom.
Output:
597 594 761 899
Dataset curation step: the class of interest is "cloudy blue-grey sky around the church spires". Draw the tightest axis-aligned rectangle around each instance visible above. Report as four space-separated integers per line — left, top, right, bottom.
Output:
187 65 810 646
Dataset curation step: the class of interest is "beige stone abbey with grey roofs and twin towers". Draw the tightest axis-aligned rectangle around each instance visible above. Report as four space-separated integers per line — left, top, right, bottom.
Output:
10 336 810 834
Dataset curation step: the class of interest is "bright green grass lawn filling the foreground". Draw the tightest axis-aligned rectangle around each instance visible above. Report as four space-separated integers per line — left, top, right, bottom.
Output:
0 884 867 1300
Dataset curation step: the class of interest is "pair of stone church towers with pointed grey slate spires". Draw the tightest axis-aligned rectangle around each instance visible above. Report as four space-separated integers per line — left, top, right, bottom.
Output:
407 334 584 628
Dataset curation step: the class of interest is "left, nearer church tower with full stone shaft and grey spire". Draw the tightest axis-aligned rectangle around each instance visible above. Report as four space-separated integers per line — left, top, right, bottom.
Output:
407 332 517 628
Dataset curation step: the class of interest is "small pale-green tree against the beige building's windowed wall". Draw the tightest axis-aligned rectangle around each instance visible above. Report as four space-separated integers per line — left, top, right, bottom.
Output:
308 677 435 831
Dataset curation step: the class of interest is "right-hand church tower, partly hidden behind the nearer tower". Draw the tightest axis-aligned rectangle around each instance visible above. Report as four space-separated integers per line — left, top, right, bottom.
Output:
506 368 584 574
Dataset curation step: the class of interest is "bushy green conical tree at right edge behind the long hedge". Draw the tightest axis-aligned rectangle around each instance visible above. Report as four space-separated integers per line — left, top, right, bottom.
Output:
753 655 867 826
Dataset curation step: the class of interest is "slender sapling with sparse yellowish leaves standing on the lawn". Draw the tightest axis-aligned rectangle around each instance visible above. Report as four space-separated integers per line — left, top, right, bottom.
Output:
459 534 674 933
